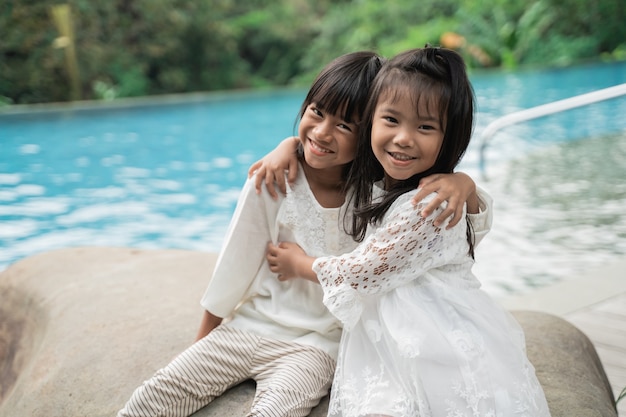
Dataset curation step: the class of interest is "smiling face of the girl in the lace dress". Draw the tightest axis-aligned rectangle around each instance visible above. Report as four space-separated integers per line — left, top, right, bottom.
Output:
371 93 445 187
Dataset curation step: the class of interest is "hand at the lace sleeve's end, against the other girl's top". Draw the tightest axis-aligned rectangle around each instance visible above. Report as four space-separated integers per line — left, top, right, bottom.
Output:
266 242 317 282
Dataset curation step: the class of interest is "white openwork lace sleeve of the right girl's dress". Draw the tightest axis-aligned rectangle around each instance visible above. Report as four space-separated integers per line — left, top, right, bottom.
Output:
313 194 467 328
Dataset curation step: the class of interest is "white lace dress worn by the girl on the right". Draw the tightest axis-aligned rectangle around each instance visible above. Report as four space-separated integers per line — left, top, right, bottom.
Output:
313 193 550 417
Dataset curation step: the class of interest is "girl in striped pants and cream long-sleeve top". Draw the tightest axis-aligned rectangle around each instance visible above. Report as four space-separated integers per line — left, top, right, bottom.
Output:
118 52 484 417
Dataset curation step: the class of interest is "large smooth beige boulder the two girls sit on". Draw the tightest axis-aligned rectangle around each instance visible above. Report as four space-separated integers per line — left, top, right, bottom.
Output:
0 248 617 417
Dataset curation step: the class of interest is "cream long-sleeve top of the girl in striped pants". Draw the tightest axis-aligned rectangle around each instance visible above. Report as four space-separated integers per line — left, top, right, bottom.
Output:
201 166 492 358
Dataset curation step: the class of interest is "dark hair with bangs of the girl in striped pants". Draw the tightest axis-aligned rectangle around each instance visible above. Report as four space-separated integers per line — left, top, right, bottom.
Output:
296 51 385 180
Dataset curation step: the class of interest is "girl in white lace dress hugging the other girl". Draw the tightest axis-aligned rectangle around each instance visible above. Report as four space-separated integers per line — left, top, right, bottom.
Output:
267 47 549 417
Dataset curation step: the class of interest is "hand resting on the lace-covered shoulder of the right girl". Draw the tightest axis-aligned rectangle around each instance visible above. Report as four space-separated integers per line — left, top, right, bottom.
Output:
412 172 478 229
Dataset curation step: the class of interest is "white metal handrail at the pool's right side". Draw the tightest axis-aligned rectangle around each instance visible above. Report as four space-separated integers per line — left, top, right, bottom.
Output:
480 84 626 174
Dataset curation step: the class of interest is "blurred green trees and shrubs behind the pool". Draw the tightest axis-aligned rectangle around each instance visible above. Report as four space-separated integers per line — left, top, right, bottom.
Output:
0 0 626 104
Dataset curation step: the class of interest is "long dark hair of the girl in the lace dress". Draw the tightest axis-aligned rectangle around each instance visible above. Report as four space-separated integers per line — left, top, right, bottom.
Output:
348 47 475 253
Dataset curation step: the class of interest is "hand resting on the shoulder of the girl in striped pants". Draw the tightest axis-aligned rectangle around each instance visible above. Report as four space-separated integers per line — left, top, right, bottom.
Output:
248 136 300 200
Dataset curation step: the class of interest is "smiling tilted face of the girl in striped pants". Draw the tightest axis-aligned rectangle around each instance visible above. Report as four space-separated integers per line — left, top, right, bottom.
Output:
298 103 357 169
